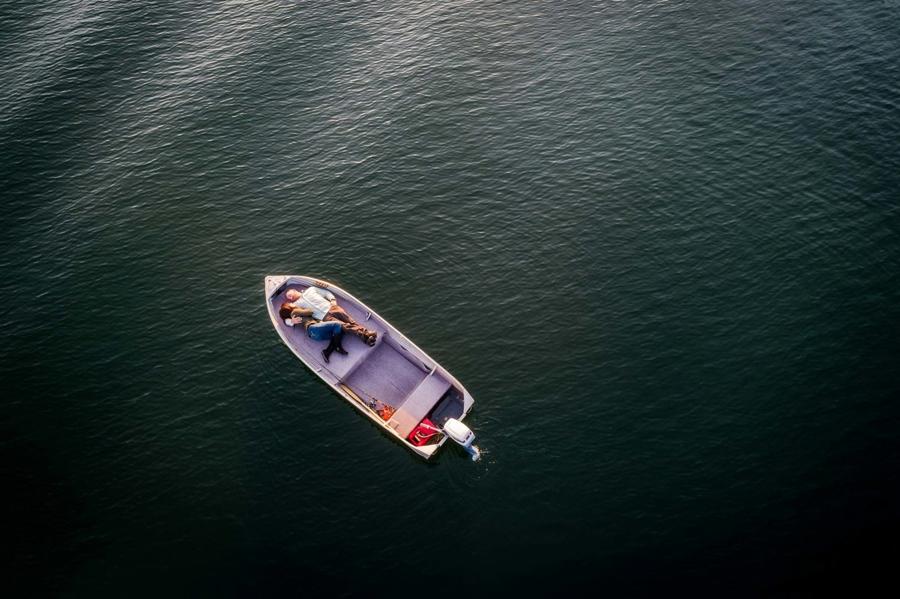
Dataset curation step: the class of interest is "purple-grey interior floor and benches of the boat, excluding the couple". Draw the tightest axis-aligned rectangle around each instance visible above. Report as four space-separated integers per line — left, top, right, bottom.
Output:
269 281 464 438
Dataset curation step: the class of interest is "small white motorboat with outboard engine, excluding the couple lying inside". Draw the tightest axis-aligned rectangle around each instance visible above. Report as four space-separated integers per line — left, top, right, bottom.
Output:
265 276 480 460
